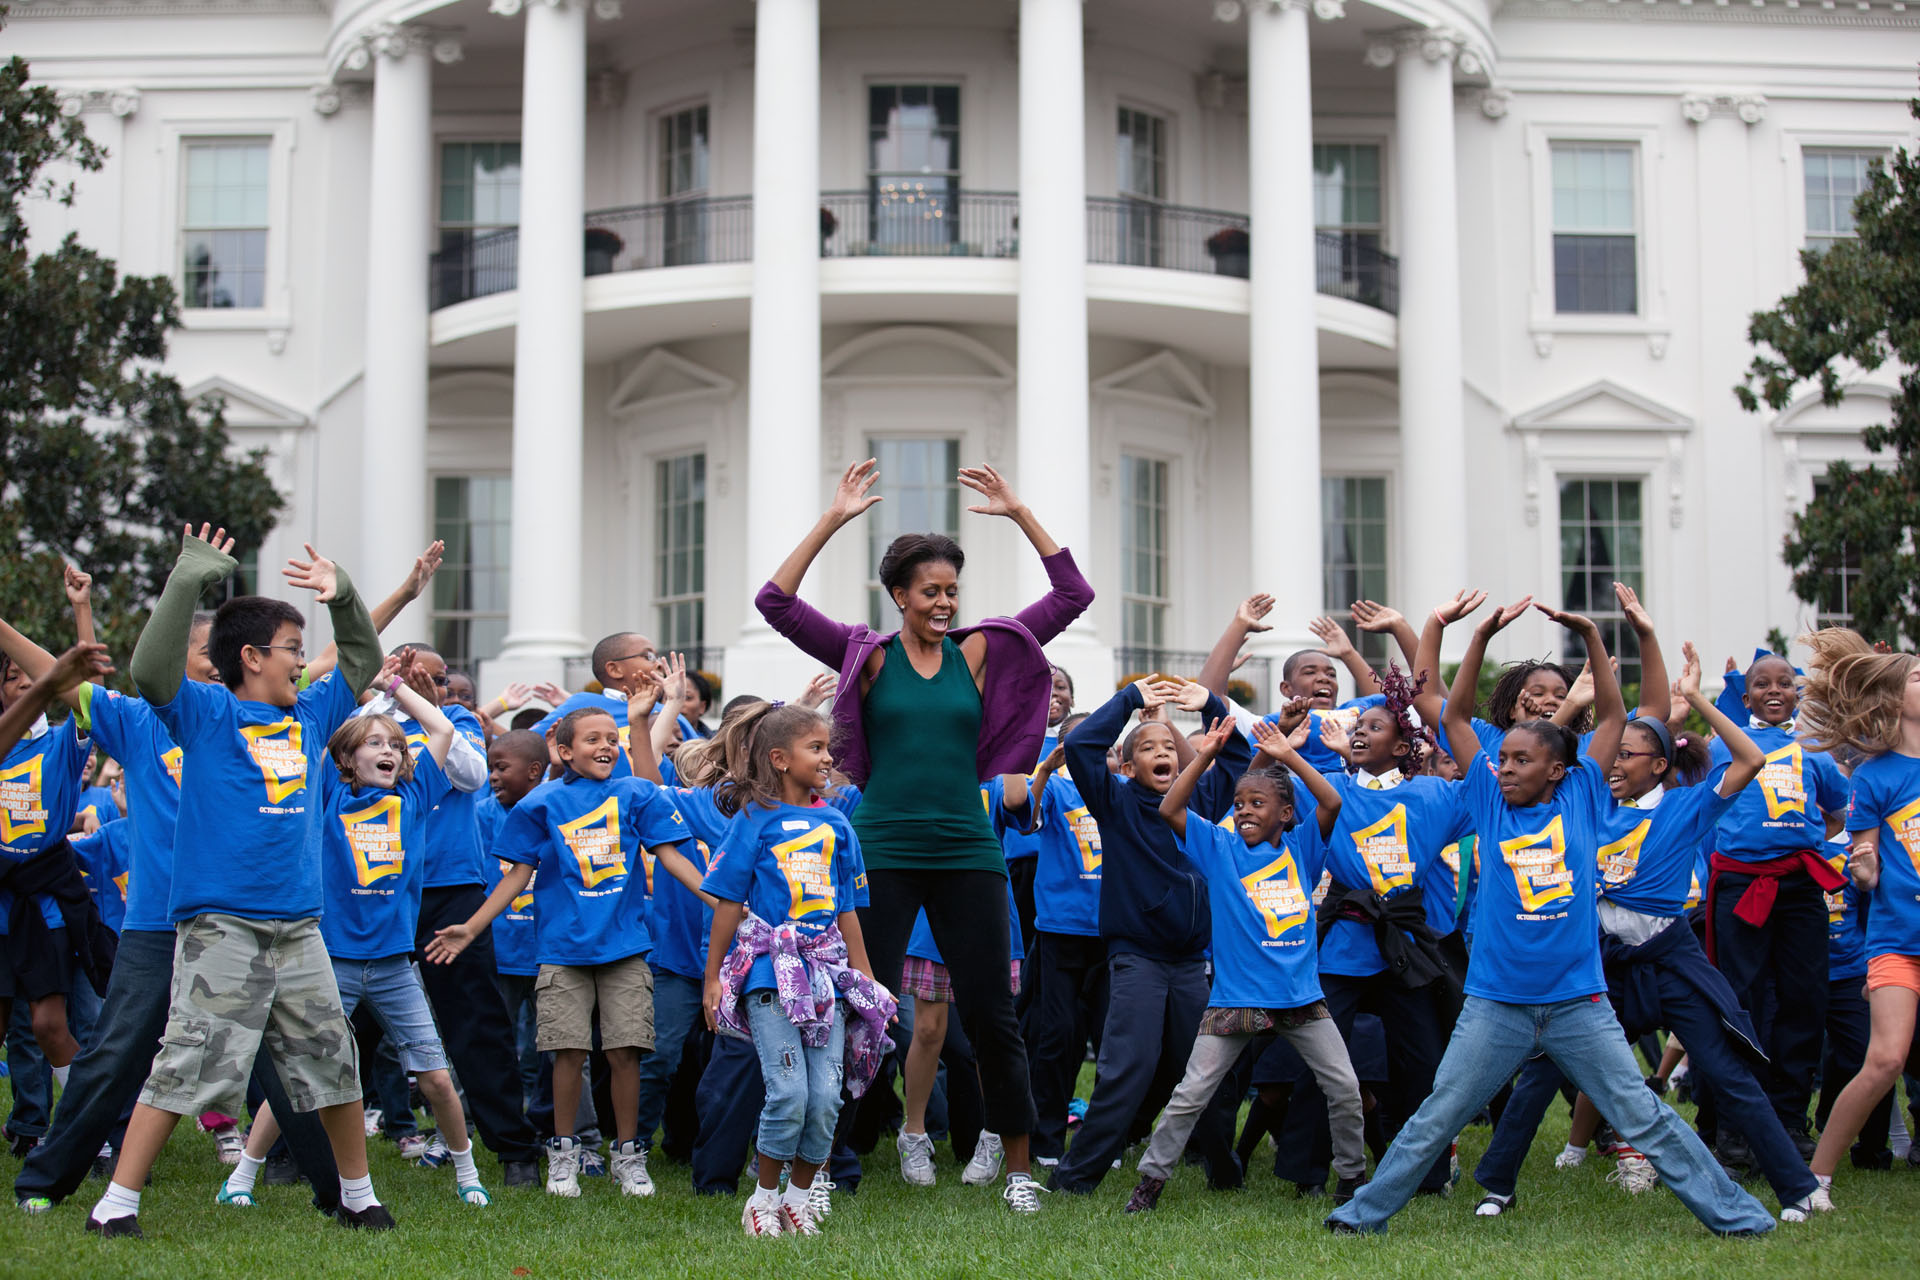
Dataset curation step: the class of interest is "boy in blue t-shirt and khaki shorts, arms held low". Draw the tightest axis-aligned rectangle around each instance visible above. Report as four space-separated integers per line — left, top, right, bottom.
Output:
426 708 701 1197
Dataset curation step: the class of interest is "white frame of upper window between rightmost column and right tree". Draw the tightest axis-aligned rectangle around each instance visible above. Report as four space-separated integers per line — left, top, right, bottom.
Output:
1526 123 1672 357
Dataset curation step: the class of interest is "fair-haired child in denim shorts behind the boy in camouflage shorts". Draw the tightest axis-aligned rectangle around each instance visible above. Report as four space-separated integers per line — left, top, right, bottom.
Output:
217 651 492 1209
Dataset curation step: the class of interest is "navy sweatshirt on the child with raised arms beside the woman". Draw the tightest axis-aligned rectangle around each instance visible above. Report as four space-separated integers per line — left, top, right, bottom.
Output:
1066 685 1254 960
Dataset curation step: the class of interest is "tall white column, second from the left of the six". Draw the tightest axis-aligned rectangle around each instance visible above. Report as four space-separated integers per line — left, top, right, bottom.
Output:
488 0 588 679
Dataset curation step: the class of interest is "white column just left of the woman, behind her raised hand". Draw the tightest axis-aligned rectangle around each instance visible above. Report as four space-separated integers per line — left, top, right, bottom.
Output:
726 0 814 697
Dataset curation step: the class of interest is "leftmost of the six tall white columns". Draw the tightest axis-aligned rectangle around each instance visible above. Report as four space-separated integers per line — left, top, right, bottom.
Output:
349 27 437 643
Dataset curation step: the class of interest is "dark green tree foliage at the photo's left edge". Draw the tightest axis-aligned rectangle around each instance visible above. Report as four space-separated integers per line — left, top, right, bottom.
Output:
0 27 280 670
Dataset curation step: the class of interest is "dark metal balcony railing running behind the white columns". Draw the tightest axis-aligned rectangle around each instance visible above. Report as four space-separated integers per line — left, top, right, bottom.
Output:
430 192 1400 313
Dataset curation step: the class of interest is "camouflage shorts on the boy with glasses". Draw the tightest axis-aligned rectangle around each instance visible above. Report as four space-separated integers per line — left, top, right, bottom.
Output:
140 913 361 1115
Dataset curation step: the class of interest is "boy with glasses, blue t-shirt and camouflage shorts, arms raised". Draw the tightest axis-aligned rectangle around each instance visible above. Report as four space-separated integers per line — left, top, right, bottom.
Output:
86 526 394 1236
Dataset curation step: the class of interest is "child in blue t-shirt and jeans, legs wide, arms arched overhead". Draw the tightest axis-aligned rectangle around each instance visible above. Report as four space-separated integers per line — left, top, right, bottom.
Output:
1327 597 1774 1234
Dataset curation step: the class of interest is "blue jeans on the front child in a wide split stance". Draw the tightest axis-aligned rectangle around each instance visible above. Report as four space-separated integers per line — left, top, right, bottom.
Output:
1327 996 1774 1234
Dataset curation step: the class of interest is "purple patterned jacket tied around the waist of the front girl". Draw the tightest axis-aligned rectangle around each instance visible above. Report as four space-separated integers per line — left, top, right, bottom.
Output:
714 912 899 1098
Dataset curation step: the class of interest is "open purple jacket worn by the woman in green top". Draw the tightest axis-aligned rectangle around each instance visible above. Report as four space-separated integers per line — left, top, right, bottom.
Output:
753 547 1092 787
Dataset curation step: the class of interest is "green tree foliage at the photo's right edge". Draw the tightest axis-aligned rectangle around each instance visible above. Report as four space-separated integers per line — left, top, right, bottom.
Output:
1734 91 1920 645
